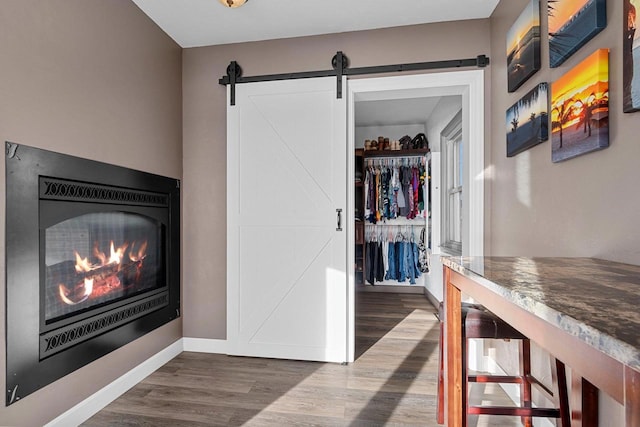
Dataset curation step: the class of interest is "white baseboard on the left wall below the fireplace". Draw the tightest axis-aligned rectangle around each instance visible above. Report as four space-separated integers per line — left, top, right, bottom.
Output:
45 338 183 427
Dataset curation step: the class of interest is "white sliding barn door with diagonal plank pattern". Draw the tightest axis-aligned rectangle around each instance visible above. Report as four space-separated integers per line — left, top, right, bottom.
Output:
227 77 350 362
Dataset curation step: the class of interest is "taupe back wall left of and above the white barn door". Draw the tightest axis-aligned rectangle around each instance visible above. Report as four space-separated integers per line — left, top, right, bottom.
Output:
183 19 491 339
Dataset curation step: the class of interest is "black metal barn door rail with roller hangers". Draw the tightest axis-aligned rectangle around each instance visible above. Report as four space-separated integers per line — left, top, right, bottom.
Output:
218 52 489 105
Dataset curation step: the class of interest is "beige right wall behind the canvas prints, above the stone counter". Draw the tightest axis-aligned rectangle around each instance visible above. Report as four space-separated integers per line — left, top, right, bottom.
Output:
486 0 640 264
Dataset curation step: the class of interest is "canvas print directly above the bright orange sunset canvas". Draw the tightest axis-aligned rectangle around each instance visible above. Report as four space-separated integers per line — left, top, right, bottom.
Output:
547 0 607 68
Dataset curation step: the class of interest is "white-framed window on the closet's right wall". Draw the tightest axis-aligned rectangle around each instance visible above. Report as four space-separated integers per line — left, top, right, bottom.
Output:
441 112 464 255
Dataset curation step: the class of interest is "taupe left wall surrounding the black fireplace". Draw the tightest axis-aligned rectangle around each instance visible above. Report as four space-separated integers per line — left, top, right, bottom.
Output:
0 0 182 426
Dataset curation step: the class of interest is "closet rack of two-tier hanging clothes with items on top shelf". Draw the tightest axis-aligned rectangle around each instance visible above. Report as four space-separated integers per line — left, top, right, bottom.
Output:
355 147 431 293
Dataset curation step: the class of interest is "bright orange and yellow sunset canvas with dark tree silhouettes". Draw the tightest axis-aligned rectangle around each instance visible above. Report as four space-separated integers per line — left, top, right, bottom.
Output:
551 49 609 162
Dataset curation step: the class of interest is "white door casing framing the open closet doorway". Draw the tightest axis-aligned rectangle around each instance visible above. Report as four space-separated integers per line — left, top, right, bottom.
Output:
347 69 485 362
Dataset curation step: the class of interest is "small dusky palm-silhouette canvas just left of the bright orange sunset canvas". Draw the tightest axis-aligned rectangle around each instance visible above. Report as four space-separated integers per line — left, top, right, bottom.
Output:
507 83 549 157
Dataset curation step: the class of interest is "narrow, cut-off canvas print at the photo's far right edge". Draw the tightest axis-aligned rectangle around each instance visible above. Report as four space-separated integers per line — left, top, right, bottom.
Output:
622 0 640 113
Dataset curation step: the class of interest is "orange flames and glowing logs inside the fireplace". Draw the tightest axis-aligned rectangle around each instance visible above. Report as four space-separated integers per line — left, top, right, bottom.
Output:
58 240 147 305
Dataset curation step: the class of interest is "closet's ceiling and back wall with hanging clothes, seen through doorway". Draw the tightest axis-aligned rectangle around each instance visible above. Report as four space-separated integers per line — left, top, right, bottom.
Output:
354 94 461 294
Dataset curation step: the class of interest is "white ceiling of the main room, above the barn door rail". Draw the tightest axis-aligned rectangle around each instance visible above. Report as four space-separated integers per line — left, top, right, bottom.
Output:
132 0 499 48
